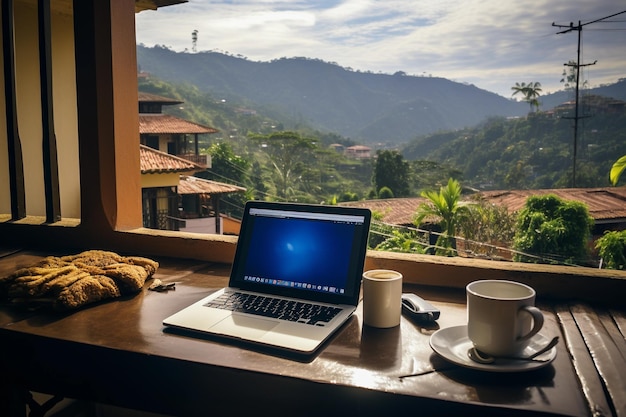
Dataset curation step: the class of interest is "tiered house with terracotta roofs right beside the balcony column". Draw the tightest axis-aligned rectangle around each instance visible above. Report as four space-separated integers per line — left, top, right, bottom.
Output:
139 92 245 234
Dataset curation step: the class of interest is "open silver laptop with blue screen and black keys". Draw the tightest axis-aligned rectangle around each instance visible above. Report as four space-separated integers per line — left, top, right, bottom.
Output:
163 201 371 354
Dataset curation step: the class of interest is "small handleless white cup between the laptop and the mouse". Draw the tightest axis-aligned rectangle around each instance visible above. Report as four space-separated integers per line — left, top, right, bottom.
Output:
363 269 402 328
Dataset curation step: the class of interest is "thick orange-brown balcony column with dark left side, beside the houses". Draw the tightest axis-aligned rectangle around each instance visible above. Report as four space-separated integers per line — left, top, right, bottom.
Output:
74 0 142 231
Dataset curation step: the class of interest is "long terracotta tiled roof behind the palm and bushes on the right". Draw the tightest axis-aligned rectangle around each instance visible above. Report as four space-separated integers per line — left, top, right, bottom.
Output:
342 187 626 226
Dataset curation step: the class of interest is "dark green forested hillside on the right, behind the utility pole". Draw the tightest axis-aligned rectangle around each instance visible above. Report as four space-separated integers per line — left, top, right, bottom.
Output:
402 102 626 189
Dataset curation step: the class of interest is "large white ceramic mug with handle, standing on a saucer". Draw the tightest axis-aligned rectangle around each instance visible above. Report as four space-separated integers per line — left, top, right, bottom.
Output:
466 280 543 356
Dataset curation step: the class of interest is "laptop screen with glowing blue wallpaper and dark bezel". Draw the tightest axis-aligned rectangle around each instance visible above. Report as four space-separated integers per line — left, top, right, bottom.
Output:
230 202 370 304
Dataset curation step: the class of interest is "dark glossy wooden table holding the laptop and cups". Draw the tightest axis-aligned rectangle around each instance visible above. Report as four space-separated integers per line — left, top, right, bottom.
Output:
0 252 626 416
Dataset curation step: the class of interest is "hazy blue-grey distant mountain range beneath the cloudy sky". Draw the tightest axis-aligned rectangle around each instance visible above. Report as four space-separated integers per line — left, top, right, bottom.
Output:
137 45 626 147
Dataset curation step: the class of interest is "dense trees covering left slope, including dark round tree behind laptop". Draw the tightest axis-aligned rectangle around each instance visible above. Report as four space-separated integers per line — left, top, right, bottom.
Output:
139 78 458 206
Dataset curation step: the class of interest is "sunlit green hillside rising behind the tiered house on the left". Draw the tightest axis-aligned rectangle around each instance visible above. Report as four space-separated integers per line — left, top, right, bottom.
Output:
139 77 372 210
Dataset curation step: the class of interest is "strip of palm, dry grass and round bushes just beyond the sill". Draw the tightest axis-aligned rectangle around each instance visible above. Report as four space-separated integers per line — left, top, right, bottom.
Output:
370 189 604 269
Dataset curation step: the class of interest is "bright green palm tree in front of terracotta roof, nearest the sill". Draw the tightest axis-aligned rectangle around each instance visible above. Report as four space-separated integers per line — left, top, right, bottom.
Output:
414 178 470 255
